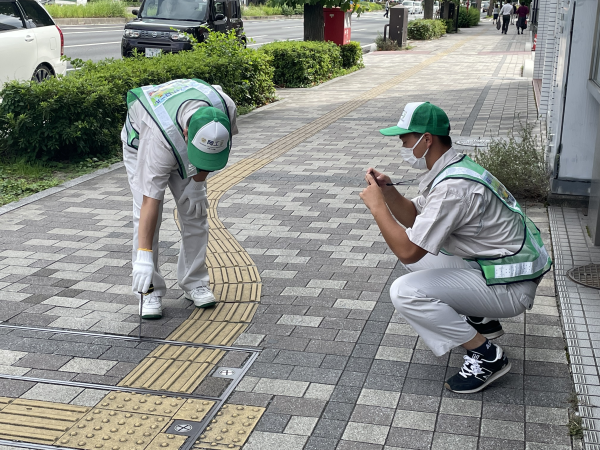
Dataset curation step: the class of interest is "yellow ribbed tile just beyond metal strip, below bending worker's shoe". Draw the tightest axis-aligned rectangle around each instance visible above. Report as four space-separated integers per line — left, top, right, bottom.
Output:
168 319 248 345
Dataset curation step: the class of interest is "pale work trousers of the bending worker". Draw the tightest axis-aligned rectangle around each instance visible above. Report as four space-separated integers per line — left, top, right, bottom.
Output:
123 145 209 297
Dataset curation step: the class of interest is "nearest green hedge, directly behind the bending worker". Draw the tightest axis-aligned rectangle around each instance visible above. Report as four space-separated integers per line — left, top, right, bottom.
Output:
0 33 275 161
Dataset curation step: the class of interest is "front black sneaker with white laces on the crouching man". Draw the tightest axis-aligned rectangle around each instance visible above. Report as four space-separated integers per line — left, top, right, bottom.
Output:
444 344 511 394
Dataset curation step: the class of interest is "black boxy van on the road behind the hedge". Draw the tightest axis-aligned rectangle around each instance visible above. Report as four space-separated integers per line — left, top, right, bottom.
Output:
121 0 246 57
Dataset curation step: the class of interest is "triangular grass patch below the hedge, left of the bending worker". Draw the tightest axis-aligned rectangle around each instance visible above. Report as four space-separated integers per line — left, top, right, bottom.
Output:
0 155 122 206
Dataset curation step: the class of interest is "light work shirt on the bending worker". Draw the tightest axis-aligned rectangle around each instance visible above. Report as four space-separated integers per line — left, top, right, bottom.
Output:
121 85 238 200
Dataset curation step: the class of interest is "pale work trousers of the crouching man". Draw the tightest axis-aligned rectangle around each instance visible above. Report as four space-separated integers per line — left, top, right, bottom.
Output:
390 253 537 356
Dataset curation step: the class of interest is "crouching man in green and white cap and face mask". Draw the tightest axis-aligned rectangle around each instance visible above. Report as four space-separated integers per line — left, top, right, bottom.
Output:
360 102 552 393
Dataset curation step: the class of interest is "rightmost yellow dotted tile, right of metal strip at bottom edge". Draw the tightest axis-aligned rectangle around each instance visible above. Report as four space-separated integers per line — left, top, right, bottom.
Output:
194 404 265 449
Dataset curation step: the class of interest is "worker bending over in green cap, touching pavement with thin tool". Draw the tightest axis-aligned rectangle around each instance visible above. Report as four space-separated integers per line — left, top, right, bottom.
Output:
121 79 237 319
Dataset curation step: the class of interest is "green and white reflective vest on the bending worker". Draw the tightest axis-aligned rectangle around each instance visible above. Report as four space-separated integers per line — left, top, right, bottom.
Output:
125 78 231 179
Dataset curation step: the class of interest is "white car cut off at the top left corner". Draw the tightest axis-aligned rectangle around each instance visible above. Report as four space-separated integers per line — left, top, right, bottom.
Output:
0 0 67 88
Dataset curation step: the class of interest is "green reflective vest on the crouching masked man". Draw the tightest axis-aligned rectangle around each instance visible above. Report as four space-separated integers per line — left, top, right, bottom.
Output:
431 156 552 286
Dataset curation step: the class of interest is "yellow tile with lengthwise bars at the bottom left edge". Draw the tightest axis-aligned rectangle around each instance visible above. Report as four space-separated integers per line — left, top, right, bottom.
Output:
0 399 90 444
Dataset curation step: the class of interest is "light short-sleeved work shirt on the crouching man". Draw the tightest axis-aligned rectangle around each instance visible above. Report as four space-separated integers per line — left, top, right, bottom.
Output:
406 148 525 258
